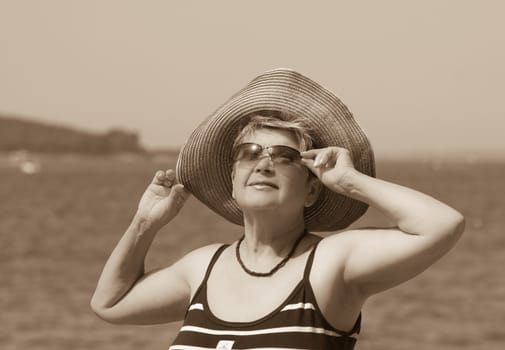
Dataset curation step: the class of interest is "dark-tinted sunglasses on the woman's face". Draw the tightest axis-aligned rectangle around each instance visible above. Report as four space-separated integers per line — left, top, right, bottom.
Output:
233 142 302 166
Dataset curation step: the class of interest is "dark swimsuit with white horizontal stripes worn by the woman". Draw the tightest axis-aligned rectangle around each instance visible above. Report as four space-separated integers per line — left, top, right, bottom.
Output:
169 245 361 350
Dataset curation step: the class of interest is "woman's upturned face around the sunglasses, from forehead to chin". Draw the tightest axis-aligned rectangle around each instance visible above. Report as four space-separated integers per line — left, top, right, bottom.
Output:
232 129 314 215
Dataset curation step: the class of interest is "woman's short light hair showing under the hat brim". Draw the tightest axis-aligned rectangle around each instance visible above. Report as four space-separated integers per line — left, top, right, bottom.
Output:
233 111 313 152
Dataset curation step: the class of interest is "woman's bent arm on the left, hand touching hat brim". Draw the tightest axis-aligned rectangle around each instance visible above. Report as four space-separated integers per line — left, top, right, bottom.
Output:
91 170 190 323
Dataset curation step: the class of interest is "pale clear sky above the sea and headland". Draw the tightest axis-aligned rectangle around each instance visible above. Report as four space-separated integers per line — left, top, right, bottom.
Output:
0 0 505 159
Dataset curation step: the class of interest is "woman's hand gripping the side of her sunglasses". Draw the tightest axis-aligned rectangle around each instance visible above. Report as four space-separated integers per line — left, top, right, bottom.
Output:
301 147 356 194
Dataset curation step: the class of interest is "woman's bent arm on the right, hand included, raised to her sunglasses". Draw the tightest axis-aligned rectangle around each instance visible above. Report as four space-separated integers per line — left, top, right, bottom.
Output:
306 147 464 298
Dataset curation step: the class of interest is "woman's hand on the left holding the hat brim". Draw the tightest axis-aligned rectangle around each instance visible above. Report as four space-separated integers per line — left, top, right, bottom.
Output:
135 169 189 230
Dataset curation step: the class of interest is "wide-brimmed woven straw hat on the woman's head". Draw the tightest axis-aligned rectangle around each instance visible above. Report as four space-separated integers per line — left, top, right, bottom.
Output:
176 68 375 231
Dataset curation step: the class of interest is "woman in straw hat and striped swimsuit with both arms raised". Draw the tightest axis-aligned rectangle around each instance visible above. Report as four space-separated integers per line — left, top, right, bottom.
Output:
91 69 464 350
